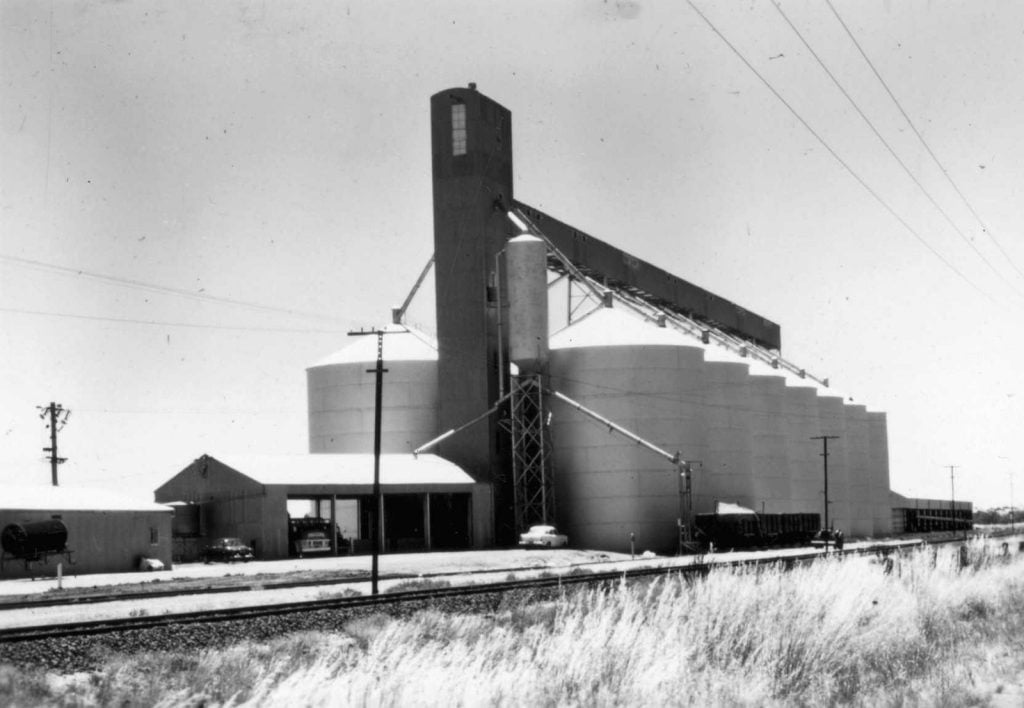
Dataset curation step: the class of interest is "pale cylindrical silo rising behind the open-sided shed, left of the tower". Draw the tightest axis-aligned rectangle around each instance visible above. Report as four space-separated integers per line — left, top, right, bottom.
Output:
306 327 437 453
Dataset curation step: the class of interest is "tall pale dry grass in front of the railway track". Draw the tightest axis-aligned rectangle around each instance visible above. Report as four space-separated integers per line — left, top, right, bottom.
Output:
0 541 1024 707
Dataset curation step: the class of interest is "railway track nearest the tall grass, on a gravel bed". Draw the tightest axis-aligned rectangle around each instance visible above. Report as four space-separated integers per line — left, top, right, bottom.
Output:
0 545 921 643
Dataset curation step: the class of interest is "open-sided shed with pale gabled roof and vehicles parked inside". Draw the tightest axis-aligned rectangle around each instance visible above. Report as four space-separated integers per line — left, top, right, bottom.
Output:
155 453 492 559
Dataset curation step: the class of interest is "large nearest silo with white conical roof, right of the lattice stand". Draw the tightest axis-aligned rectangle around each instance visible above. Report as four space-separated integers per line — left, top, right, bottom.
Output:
550 308 705 552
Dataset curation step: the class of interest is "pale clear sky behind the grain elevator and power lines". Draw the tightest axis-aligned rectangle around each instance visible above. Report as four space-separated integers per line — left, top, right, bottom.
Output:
0 0 1024 506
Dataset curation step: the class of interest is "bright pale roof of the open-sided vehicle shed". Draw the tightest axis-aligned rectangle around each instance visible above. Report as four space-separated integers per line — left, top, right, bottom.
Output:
212 453 475 486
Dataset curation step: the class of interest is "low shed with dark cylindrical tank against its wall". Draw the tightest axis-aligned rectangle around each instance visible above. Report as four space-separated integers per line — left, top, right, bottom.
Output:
0 486 174 579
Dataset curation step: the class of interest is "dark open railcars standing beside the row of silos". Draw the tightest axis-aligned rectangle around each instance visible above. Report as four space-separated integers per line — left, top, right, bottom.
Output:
694 507 821 550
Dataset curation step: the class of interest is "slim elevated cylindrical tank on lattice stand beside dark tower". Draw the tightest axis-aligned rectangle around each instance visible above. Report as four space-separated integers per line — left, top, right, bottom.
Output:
505 234 548 375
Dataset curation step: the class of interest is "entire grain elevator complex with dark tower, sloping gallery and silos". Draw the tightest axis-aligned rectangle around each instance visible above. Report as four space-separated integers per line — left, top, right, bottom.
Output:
307 84 892 551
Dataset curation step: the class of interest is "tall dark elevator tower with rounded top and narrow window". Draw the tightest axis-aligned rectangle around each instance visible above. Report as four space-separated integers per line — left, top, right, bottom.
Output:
430 84 513 512
